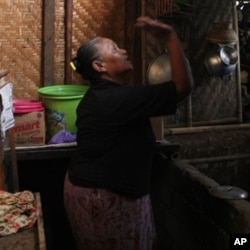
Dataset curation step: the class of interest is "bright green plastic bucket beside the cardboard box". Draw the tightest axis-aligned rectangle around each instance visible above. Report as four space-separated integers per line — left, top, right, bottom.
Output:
38 85 89 140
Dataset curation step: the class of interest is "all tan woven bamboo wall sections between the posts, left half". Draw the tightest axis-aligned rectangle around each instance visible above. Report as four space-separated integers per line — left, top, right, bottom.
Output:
0 0 125 99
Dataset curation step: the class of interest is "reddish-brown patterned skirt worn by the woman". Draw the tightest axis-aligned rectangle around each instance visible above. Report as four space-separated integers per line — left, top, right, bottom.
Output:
64 174 157 250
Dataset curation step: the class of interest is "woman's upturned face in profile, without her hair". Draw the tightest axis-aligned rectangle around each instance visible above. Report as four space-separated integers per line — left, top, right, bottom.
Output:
95 38 133 79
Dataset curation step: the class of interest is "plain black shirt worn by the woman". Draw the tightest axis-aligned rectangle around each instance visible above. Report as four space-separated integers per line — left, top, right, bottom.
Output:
69 80 177 198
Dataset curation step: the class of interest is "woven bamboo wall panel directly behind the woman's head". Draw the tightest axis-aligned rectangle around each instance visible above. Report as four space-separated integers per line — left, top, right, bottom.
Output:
72 0 125 83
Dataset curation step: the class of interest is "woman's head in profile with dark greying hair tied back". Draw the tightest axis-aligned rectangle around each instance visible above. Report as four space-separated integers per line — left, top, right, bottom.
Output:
72 37 133 81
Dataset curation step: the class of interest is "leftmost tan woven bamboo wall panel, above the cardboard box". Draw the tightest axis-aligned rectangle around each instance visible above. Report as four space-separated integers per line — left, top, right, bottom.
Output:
0 0 41 98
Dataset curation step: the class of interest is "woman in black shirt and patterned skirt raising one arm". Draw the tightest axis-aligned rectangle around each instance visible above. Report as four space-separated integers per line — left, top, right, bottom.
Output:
64 17 192 250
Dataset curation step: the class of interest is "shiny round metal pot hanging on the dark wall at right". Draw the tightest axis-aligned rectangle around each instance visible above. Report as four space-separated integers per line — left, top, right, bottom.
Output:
205 45 238 76
